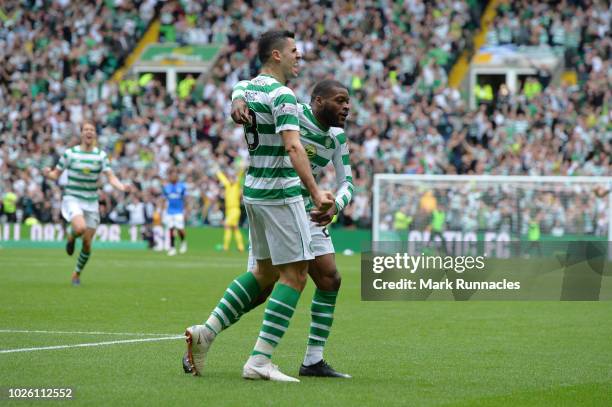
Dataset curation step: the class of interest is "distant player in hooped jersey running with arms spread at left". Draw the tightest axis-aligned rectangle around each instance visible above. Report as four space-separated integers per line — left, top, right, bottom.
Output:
43 121 131 286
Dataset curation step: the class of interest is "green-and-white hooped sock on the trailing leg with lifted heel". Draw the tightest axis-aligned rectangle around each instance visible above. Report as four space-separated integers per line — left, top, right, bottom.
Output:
204 272 261 335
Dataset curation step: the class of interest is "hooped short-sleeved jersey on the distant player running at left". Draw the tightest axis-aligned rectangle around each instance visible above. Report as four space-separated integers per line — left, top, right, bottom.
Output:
56 146 111 203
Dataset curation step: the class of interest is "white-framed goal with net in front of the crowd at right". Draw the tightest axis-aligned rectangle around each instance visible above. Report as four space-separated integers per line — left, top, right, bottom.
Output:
372 174 612 241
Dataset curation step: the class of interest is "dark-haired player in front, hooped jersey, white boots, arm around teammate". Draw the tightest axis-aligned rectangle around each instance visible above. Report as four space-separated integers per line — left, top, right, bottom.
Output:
185 31 334 382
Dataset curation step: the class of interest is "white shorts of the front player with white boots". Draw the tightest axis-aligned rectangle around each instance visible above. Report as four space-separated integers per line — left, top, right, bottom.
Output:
244 201 314 265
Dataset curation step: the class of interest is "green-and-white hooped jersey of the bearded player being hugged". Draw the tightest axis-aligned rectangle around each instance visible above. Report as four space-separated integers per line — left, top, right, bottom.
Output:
299 103 355 212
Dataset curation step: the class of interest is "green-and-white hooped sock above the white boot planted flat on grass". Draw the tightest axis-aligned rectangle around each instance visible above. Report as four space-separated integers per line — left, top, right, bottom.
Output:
251 283 301 358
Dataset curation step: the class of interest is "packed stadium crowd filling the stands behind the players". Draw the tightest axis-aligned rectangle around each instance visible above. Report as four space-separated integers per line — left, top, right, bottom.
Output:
0 0 612 233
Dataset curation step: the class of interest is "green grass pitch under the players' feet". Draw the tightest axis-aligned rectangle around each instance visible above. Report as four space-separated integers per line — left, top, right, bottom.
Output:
0 249 612 406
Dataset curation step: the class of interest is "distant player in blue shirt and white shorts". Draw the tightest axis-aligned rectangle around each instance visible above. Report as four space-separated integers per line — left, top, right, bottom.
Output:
162 168 187 256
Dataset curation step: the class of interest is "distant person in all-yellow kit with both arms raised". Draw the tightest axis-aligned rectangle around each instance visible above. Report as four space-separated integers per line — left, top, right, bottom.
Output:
217 168 244 252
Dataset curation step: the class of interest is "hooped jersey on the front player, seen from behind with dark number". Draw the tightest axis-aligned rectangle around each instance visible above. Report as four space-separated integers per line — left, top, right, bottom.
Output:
232 75 302 205
